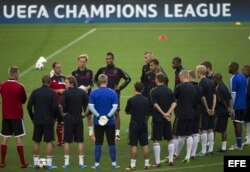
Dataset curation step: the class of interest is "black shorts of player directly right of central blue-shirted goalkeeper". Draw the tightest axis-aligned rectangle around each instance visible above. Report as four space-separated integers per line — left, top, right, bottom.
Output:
129 126 148 146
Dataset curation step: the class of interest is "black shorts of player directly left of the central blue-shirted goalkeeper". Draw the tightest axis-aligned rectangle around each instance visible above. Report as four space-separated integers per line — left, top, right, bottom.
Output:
63 122 84 143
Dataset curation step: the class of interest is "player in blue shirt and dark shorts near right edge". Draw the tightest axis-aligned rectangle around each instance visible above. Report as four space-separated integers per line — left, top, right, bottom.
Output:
228 62 247 150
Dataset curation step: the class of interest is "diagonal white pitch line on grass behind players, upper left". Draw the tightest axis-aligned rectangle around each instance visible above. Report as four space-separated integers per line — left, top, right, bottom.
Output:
19 28 96 77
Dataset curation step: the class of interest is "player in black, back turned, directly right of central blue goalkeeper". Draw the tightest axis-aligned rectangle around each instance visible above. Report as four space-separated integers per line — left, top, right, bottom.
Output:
125 82 150 171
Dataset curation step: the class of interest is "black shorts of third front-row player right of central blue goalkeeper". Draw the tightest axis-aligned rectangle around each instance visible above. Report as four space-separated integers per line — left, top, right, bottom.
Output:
177 118 194 136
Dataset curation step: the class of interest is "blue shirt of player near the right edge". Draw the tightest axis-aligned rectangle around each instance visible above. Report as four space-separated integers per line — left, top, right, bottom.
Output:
230 73 247 110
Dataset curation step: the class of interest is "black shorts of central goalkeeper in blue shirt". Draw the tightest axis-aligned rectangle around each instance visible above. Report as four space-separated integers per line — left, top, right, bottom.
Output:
94 125 115 145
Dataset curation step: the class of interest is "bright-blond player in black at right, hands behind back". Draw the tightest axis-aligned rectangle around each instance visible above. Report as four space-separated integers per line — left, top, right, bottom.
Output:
196 65 216 156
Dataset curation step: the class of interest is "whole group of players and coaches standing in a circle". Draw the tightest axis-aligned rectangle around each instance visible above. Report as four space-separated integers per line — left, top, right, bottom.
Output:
0 51 250 170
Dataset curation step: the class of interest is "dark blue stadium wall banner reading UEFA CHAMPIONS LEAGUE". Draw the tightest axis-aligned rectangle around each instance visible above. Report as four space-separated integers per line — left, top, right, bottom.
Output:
0 0 250 24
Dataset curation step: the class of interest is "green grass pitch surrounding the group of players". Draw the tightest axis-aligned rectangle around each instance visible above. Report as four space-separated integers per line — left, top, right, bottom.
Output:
0 23 250 172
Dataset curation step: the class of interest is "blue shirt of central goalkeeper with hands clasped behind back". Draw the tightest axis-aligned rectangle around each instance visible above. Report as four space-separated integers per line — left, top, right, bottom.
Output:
89 87 118 125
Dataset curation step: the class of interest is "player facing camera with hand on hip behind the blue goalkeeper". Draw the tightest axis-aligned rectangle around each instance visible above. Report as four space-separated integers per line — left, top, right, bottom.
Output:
94 52 131 140
